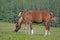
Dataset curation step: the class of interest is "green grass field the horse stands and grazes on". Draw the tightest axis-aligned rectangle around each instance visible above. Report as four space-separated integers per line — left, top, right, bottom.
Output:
0 21 60 40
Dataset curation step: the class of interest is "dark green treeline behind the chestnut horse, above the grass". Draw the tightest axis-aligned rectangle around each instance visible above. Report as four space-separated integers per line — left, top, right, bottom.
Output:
0 0 60 25
